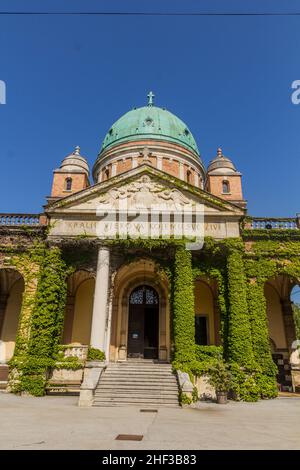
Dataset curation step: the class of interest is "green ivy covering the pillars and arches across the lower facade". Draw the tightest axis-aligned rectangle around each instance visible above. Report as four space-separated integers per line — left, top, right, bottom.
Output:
0 233 300 401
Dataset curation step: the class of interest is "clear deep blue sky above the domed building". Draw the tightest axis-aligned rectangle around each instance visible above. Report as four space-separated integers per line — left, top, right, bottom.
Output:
0 0 300 216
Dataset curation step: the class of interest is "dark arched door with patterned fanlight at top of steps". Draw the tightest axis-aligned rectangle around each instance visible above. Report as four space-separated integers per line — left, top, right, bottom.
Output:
127 285 159 359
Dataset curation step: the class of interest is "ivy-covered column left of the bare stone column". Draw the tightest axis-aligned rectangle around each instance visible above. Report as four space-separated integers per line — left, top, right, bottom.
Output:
10 248 68 396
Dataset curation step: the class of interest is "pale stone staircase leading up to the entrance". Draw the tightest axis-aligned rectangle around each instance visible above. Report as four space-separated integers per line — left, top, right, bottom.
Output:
93 360 179 408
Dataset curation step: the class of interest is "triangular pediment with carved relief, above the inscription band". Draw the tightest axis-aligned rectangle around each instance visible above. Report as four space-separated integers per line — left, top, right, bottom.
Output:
46 165 244 216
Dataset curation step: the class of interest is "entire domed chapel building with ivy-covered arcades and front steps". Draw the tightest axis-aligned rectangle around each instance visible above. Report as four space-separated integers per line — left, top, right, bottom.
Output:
0 92 300 406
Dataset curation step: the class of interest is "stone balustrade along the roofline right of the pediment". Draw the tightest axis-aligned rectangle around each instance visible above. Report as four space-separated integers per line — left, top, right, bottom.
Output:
244 214 300 230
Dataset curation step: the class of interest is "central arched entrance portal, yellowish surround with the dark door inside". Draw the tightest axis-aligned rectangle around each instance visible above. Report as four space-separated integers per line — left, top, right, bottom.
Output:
109 259 171 361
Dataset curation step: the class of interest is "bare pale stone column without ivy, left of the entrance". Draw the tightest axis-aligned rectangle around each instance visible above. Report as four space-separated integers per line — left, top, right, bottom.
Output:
91 246 110 351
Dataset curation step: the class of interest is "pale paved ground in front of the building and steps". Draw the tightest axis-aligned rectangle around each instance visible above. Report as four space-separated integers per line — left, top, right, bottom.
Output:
0 393 300 450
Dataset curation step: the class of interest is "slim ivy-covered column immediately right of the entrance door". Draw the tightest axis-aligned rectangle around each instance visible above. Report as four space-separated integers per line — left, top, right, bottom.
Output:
173 247 195 363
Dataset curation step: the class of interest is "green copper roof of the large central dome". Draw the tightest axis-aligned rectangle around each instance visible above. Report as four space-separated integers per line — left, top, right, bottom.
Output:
100 105 199 155
